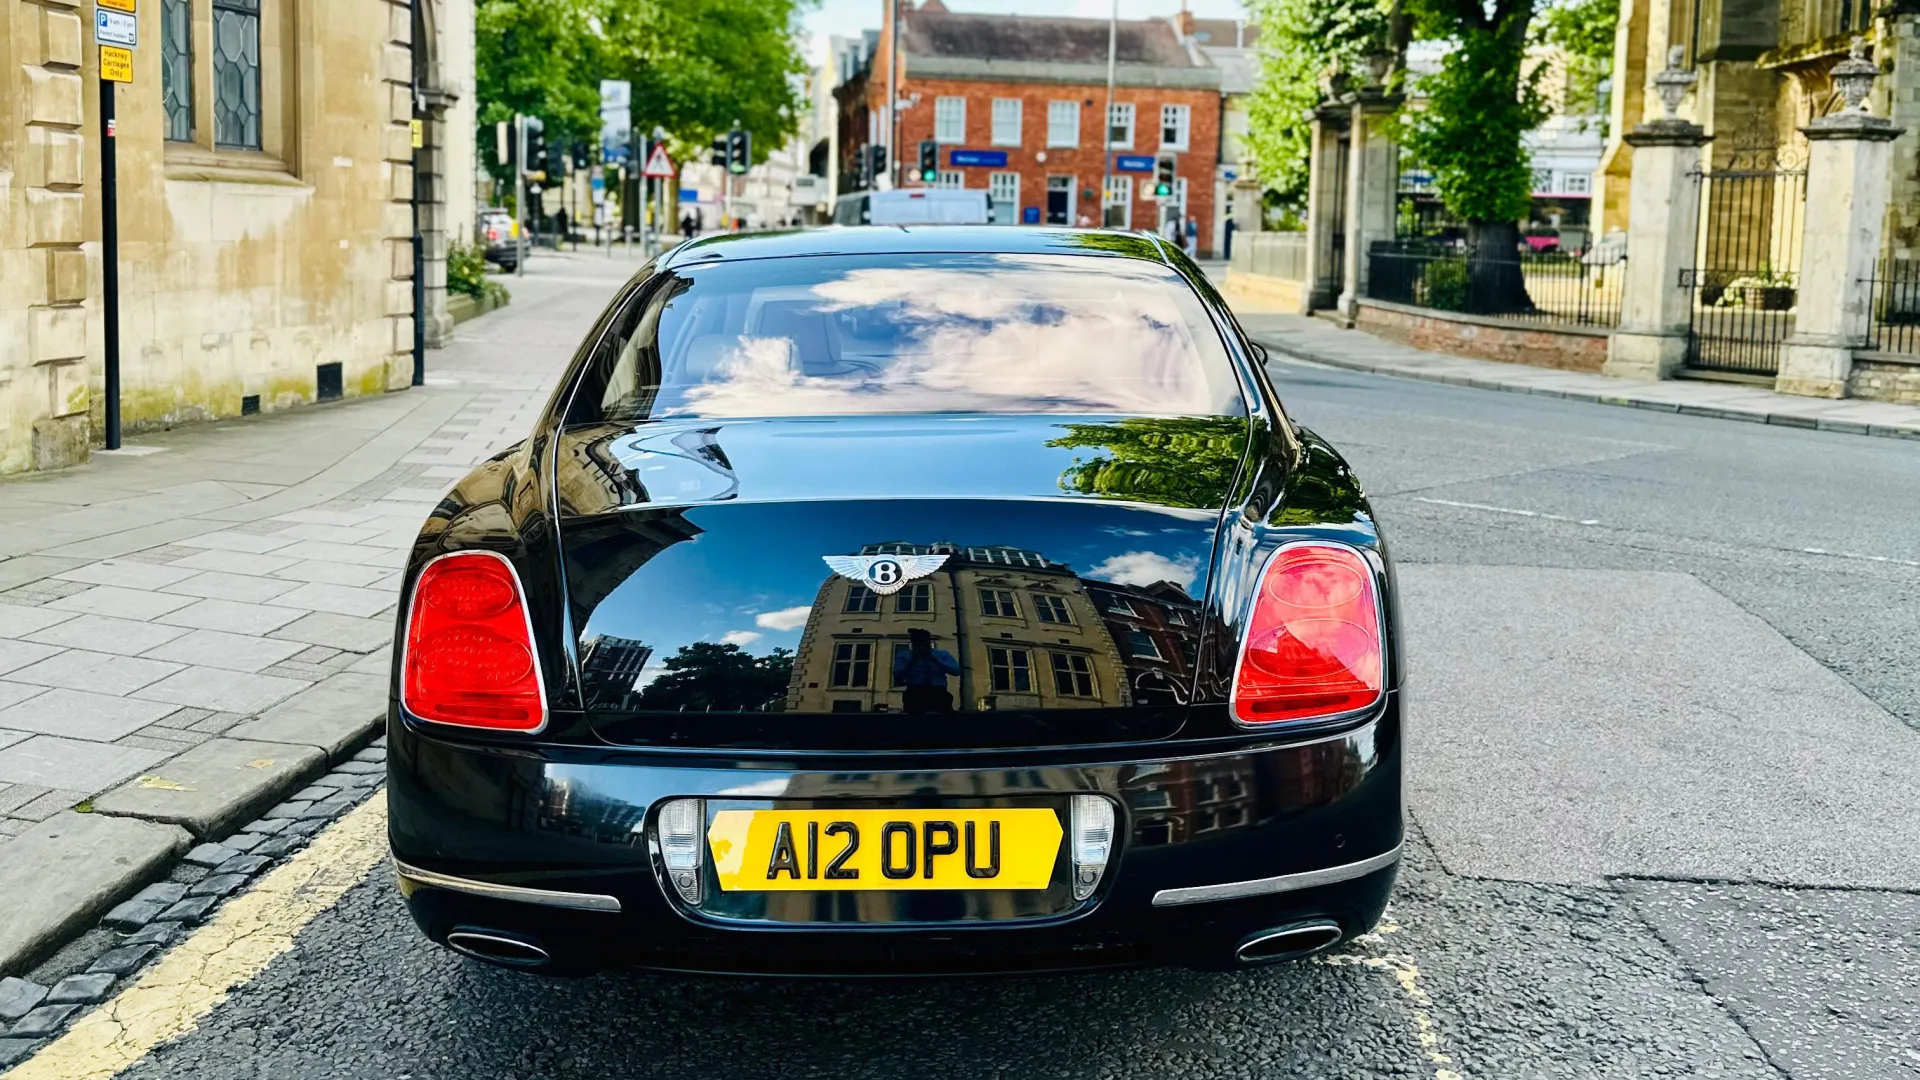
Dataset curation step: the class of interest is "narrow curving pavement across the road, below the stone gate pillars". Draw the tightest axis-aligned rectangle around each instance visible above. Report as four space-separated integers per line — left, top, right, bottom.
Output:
1236 311 1920 438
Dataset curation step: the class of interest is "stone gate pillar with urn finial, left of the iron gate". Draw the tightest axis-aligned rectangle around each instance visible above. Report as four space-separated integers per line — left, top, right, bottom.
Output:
1601 50 1711 380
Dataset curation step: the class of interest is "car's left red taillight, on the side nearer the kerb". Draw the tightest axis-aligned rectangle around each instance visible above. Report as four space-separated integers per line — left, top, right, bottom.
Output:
401 552 547 732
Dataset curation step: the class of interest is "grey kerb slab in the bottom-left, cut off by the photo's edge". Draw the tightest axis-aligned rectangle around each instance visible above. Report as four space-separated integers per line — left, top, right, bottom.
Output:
0 811 190 974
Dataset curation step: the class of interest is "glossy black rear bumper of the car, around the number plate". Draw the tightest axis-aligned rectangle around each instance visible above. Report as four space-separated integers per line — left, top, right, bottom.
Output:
388 694 1402 976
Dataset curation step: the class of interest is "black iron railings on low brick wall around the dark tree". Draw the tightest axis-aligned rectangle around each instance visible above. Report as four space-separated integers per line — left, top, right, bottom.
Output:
1367 240 1626 327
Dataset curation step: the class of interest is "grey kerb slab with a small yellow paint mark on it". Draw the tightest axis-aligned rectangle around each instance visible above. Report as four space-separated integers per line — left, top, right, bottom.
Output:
94 738 324 838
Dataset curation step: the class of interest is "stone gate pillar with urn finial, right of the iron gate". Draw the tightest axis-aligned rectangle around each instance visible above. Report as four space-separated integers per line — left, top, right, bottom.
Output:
1774 38 1901 398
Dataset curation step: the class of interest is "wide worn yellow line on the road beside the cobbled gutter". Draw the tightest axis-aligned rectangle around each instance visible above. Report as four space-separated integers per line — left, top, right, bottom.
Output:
6 792 388 1080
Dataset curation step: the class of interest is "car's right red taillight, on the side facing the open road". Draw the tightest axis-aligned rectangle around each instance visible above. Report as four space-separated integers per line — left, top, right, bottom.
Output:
1233 544 1384 724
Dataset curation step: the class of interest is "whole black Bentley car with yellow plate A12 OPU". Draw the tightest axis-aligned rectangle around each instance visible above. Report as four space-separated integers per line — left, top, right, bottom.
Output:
388 227 1402 974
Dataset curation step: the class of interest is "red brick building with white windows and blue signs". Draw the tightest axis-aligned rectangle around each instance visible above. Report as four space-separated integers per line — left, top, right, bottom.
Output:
837 0 1221 256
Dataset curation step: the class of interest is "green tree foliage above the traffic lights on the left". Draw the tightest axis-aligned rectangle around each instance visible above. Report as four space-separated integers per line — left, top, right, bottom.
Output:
474 0 814 178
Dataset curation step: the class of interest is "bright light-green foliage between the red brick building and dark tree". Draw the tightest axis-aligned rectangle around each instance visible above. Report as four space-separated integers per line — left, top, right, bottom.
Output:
1246 0 1388 204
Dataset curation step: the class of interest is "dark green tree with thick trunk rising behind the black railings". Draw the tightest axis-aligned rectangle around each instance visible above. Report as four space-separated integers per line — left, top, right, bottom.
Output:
1398 0 1548 313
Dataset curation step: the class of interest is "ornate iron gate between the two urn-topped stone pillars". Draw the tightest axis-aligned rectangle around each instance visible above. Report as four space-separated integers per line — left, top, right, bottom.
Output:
1680 133 1807 379
